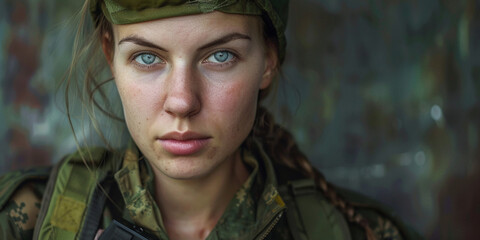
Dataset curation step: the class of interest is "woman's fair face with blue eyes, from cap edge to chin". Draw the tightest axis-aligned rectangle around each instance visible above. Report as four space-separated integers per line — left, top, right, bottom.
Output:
110 12 276 179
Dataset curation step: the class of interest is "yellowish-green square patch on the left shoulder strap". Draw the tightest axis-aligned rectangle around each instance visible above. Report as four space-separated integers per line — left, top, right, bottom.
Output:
51 195 85 232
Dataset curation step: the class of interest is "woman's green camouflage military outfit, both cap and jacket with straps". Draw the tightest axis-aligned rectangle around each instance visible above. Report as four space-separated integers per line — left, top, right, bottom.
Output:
0 0 424 240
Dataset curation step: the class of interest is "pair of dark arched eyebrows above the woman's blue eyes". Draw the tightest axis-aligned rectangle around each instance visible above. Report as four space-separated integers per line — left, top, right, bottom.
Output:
118 33 252 52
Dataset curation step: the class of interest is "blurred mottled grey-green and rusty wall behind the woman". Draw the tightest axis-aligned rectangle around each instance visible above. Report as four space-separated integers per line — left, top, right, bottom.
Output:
0 0 480 239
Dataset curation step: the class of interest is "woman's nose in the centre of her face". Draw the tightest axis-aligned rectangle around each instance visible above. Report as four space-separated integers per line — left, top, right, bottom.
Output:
163 66 201 118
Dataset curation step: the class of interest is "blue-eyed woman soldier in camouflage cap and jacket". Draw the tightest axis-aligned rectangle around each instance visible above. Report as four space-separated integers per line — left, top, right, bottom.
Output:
0 0 415 239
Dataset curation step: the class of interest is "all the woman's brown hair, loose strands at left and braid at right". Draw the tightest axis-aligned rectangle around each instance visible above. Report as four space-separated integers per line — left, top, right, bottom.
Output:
63 0 376 240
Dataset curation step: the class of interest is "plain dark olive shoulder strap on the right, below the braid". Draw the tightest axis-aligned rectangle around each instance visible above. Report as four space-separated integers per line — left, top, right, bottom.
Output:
280 179 351 240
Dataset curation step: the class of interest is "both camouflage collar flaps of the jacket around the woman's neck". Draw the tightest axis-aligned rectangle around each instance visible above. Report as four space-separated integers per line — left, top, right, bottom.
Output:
115 142 285 240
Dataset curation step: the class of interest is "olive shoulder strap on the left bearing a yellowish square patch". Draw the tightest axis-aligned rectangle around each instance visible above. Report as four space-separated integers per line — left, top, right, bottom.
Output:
33 148 116 239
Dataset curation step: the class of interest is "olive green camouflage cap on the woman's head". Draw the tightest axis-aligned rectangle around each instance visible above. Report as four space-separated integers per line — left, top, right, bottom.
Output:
90 0 289 62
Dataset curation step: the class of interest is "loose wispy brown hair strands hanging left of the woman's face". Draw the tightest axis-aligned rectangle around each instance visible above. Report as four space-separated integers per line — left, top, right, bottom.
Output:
61 0 122 159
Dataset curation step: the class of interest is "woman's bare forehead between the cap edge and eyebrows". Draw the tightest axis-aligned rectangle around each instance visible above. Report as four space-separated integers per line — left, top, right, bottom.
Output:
113 11 262 42
